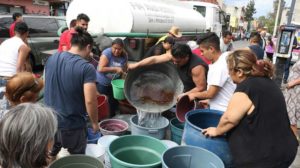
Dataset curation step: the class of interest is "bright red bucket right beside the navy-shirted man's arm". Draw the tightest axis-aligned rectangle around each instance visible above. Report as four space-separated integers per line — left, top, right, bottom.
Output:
97 95 109 121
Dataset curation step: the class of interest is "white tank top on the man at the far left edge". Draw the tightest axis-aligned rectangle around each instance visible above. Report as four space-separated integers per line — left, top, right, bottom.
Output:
0 36 25 77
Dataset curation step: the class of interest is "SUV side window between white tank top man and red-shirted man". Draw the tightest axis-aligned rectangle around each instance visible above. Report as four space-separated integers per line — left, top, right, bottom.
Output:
24 18 59 37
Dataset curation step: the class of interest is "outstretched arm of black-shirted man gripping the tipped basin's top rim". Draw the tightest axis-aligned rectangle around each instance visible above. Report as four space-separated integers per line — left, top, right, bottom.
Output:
128 53 172 69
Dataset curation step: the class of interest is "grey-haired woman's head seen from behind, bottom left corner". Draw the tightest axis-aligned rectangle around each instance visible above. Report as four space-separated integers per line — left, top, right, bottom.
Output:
0 103 57 168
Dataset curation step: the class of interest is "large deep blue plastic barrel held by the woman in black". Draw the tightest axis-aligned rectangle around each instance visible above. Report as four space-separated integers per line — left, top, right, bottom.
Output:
181 109 232 167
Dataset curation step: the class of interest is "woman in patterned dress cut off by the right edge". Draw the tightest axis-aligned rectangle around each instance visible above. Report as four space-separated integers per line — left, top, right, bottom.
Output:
285 61 300 141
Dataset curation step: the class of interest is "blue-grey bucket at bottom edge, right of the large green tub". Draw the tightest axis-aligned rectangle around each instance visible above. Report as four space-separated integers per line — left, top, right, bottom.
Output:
162 146 224 168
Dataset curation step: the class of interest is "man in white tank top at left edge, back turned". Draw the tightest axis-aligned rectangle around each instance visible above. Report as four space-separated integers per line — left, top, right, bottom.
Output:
0 22 30 79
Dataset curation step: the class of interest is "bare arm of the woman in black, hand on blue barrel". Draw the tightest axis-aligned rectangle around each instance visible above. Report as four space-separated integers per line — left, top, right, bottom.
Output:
203 92 254 137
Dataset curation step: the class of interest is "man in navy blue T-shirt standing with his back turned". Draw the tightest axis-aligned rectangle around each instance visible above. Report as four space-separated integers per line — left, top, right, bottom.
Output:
44 28 99 158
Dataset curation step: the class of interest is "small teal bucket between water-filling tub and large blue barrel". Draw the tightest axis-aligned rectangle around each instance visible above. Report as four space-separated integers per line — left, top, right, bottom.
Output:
170 118 184 144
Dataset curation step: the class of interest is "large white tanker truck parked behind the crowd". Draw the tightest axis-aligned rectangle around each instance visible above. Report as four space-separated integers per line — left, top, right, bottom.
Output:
66 0 226 61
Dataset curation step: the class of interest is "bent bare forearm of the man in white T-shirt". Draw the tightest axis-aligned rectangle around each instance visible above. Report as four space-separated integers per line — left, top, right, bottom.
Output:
188 85 220 100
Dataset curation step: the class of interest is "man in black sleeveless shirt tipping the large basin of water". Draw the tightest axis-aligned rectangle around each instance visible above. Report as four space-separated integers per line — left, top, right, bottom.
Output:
128 44 208 97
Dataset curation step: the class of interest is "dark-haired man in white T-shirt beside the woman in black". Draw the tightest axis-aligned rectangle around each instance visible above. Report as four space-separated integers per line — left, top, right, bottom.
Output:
188 33 236 111
